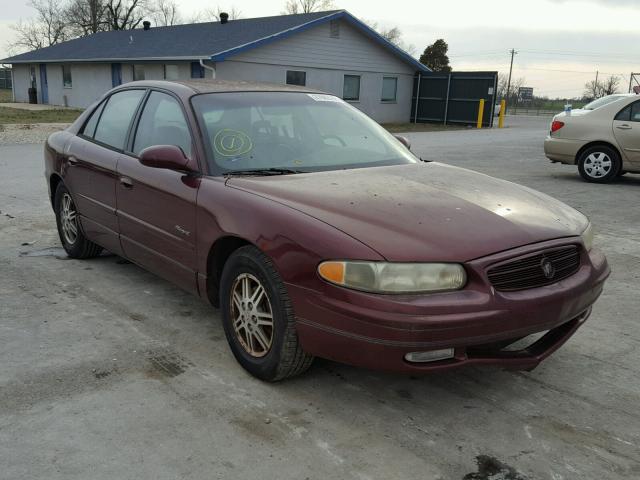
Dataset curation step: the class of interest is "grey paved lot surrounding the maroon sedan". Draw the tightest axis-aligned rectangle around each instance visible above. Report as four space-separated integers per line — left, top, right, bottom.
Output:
0 117 640 480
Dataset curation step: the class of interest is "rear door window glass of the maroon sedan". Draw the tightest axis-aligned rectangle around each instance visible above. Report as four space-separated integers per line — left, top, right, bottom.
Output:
93 90 145 150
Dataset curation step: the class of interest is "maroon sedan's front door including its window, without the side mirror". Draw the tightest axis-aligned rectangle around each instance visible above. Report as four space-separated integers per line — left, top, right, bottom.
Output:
116 91 200 291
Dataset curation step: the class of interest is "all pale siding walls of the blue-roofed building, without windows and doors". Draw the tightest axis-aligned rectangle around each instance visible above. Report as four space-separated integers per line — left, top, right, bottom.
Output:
7 21 415 122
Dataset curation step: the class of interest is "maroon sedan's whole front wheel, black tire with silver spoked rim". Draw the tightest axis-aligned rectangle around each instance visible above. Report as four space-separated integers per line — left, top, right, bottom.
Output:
220 246 313 382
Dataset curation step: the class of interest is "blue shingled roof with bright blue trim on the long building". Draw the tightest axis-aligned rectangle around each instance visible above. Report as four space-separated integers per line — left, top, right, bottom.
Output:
0 10 429 71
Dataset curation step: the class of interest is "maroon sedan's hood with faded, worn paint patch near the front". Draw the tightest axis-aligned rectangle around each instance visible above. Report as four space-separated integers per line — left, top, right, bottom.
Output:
227 162 588 261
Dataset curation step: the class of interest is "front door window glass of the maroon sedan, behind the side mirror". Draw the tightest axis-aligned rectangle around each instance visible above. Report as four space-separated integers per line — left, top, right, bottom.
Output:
133 92 191 157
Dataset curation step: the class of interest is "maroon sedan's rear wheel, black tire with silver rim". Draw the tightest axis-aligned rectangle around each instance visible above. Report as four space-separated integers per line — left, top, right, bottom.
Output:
53 183 102 259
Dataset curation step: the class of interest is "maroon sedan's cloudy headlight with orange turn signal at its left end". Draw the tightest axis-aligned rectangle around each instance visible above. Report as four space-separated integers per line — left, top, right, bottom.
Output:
318 261 467 293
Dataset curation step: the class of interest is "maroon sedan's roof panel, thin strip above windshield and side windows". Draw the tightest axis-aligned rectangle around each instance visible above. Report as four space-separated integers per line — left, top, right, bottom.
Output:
122 79 331 95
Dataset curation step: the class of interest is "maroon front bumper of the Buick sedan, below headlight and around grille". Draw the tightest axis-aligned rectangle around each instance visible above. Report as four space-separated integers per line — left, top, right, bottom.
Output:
287 240 610 373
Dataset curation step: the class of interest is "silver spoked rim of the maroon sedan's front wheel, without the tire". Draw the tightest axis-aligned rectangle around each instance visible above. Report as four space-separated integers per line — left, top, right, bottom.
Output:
230 273 273 358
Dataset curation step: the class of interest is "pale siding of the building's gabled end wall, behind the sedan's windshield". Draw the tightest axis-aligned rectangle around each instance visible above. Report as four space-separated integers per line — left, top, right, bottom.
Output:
216 22 415 123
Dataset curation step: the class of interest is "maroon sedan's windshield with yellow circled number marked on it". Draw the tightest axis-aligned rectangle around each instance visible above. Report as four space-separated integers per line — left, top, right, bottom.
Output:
191 92 417 175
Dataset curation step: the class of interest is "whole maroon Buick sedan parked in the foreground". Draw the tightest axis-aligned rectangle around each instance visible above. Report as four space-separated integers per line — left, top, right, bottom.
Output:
45 81 609 381
